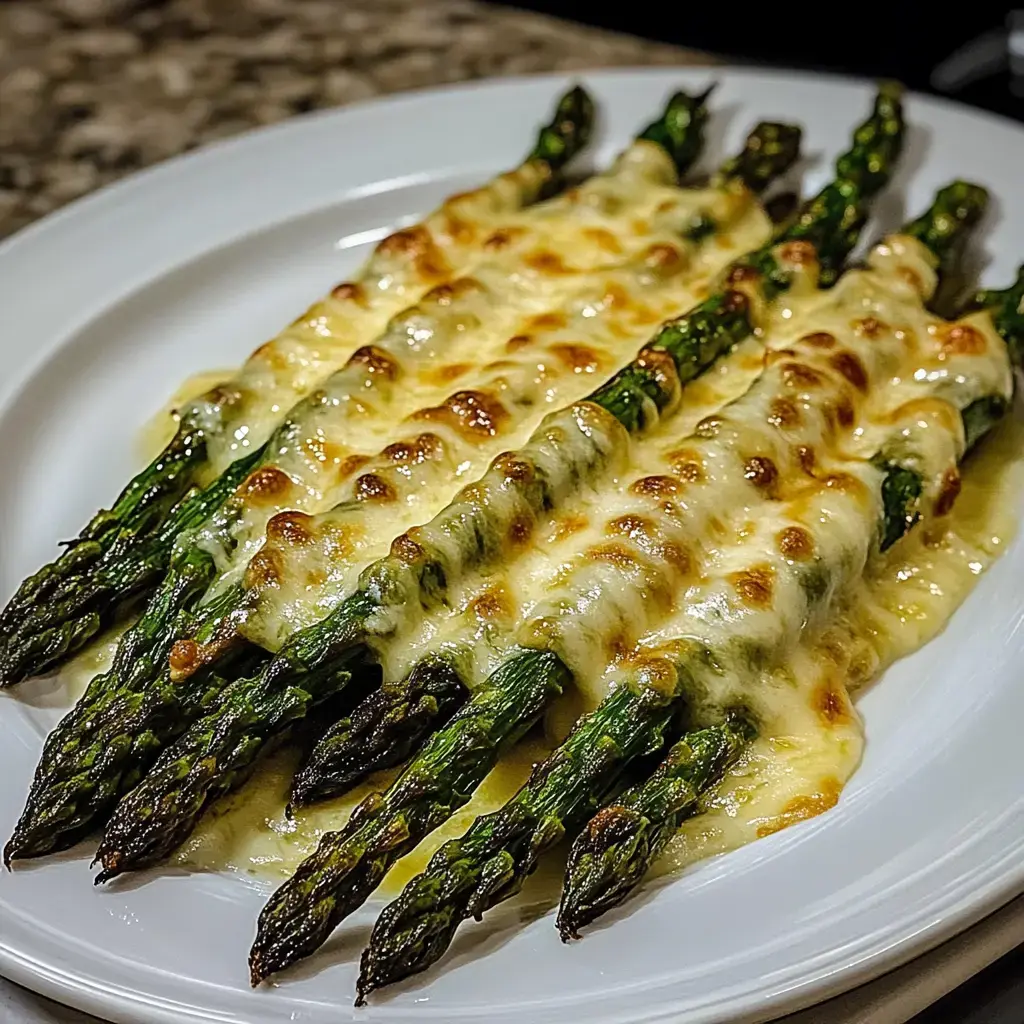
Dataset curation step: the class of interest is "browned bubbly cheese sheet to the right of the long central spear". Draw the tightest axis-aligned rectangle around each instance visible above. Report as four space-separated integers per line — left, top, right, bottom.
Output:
368 234 1011 702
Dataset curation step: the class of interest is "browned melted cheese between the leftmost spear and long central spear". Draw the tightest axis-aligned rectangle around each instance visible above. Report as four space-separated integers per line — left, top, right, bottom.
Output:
172 171 769 663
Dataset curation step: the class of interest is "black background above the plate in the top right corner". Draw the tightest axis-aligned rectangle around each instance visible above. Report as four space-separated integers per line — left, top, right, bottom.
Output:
485 0 1024 121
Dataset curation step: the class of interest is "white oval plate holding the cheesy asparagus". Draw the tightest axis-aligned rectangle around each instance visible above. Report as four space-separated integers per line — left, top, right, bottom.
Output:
0 70 1024 1024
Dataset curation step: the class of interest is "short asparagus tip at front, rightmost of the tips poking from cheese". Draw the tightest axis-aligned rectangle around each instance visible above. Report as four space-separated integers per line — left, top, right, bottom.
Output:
557 715 757 942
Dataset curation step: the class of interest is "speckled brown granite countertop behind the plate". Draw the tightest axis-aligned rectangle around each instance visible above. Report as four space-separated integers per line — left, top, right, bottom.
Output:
0 0 707 237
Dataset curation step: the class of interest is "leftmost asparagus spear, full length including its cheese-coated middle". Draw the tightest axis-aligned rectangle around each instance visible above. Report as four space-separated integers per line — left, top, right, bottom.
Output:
0 87 598 685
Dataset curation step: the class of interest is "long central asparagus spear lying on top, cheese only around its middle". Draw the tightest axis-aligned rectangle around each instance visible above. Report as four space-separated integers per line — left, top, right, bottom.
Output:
83 91 901 880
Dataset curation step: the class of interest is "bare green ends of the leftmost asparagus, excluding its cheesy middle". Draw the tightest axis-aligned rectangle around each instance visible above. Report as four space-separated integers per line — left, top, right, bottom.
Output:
0 87 598 685
